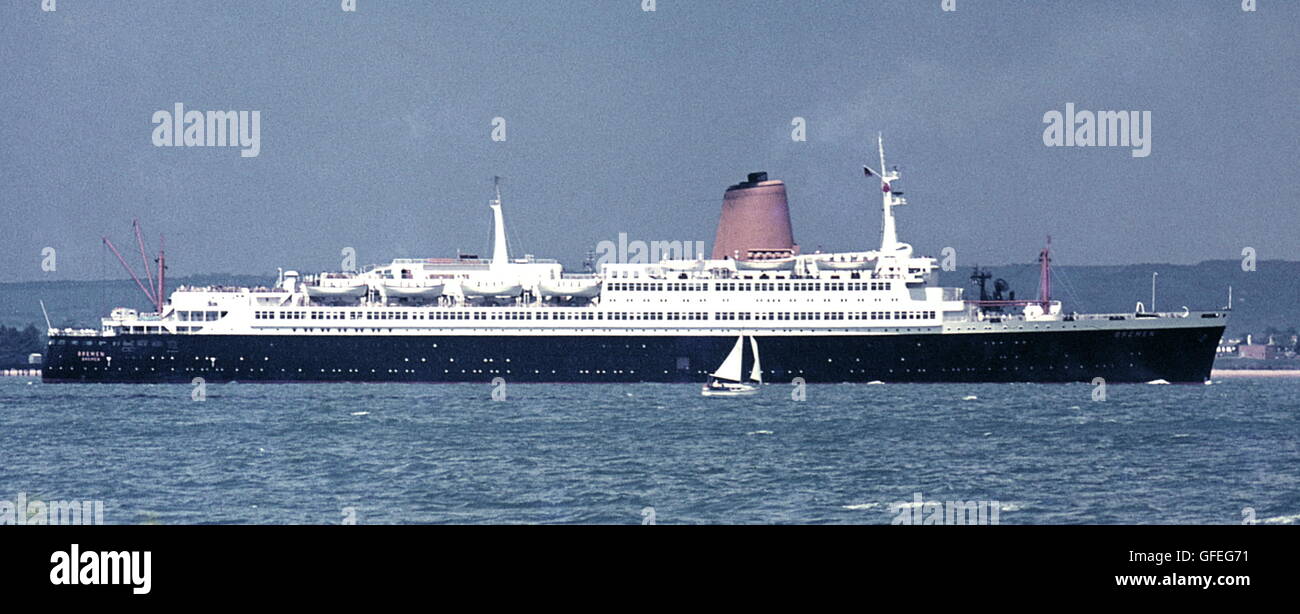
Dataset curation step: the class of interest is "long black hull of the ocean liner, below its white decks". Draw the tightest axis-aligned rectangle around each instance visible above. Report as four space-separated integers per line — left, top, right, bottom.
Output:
43 323 1223 384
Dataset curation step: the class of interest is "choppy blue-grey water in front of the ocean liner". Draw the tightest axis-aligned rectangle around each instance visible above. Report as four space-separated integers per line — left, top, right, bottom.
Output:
0 377 1300 524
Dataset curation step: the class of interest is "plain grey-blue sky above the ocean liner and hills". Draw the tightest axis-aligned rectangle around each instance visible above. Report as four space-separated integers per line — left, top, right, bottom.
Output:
0 0 1300 281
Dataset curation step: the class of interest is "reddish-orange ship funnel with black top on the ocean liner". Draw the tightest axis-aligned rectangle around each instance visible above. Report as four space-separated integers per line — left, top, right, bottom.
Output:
712 172 800 260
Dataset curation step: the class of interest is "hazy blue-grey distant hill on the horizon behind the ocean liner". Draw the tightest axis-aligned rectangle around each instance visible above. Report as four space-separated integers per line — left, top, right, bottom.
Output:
0 260 1300 336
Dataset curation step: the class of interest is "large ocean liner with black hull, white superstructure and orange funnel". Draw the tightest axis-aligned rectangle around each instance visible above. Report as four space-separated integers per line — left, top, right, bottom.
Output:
43 138 1227 384
